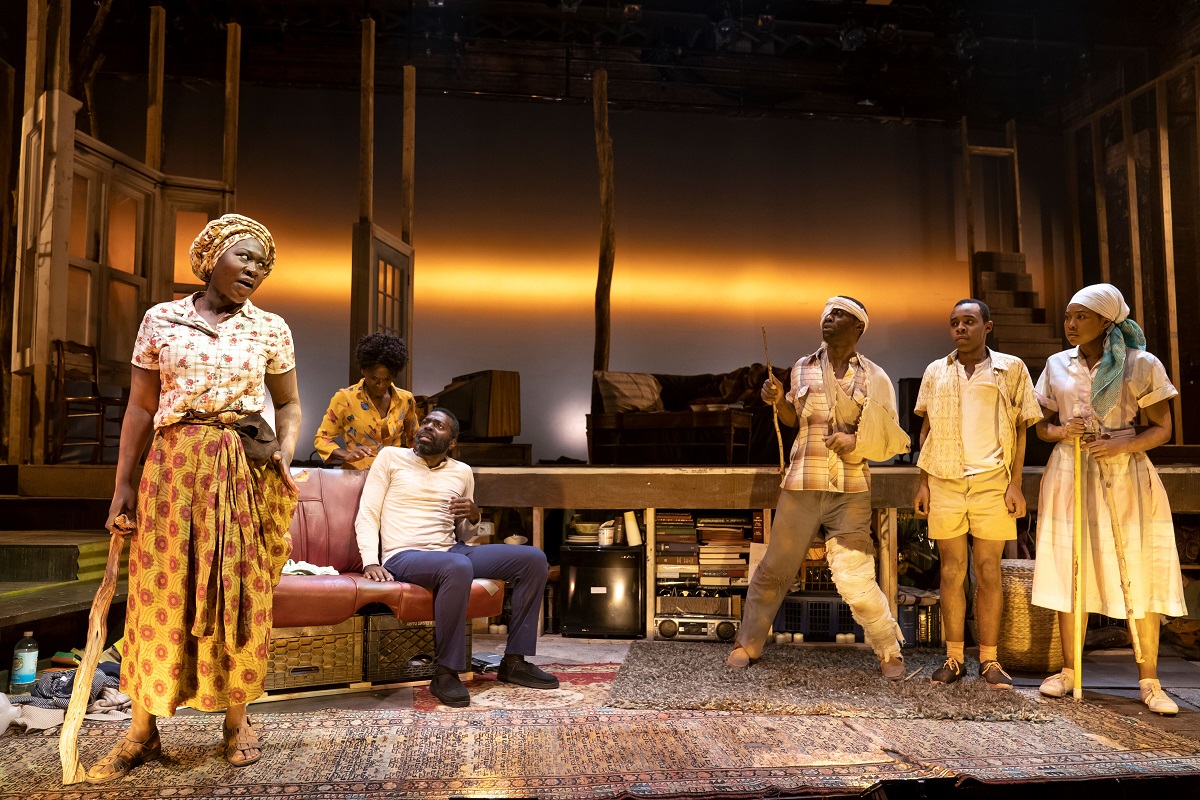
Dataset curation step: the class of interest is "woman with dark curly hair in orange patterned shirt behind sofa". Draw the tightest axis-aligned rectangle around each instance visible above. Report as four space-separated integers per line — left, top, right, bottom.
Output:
313 331 416 469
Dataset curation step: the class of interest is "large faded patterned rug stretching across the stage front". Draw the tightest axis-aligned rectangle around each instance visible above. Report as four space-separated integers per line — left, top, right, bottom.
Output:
0 664 1200 800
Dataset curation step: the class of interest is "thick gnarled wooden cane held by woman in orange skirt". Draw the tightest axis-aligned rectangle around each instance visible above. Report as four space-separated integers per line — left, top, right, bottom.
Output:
59 513 137 786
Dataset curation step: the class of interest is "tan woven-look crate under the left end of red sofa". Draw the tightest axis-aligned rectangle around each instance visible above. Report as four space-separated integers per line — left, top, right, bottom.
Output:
266 616 362 690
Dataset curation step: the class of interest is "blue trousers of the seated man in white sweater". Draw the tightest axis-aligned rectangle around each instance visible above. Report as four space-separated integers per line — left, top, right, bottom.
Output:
384 545 548 672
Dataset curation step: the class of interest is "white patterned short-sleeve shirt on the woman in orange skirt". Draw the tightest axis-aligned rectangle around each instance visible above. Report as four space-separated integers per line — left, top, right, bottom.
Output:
133 293 296 428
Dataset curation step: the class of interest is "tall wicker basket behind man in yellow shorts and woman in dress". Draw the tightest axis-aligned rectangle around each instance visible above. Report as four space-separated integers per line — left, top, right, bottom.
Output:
997 559 1062 672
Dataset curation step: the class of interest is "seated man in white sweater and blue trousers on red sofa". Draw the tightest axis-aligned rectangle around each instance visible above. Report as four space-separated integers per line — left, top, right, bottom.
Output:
354 408 558 708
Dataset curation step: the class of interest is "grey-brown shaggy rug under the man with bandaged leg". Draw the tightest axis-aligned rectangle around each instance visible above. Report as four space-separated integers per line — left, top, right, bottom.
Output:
607 642 1061 722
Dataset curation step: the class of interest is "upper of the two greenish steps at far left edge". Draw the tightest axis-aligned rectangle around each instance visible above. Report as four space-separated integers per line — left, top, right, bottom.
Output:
0 530 128 583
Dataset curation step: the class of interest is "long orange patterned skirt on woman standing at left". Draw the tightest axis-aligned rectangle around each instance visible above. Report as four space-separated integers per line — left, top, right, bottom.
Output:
121 422 296 716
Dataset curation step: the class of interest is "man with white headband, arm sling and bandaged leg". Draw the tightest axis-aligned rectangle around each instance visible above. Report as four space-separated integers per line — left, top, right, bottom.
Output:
726 295 908 680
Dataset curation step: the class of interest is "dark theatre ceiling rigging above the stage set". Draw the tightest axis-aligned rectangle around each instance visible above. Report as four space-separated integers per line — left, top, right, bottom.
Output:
0 0 1198 127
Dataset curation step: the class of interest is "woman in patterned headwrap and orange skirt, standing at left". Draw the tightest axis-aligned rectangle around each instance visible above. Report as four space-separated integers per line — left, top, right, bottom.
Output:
88 213 300 783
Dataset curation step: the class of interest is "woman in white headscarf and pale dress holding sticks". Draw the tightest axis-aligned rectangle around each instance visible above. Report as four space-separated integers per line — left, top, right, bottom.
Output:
1033 283 1186 714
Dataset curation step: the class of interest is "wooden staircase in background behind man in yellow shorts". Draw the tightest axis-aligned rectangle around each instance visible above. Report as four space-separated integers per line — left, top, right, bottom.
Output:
971 252 1063 380
